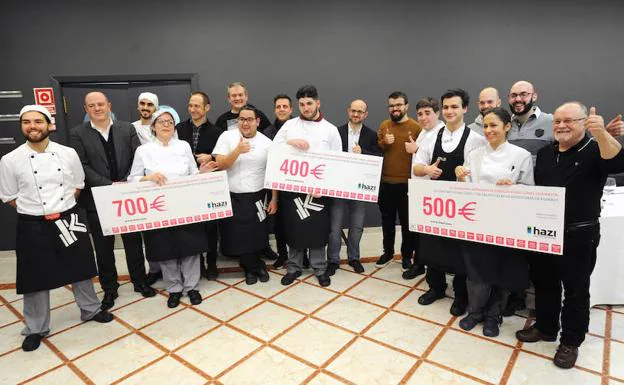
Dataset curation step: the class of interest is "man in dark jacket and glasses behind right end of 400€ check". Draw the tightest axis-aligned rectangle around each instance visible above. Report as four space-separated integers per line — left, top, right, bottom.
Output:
327 99 381 275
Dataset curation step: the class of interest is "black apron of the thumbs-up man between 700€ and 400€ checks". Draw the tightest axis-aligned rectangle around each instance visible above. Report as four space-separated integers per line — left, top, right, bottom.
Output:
220 190 269 256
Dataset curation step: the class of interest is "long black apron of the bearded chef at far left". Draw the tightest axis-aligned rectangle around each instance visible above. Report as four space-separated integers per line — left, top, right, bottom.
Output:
15 206 97 294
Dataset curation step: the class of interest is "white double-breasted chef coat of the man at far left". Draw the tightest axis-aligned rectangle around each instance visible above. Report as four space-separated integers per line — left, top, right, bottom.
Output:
0 141 85 216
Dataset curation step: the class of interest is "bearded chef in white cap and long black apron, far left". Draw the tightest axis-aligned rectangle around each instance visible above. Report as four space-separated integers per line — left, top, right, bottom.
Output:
0 105 113 351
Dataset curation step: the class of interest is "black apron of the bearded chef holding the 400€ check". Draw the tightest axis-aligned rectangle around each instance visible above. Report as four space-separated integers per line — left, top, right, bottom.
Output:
280 191 330 250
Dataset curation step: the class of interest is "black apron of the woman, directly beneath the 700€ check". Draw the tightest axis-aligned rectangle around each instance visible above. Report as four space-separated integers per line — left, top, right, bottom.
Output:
143 223 208 262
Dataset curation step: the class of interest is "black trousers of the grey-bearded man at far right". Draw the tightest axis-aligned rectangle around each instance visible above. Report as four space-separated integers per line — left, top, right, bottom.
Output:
529 226 600 346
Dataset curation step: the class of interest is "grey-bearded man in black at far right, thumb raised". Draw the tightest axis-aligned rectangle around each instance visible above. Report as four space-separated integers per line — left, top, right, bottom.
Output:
516 102 624 369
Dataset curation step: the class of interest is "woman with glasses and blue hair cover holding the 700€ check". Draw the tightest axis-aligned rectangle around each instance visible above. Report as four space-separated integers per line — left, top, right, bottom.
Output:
128 110 216 308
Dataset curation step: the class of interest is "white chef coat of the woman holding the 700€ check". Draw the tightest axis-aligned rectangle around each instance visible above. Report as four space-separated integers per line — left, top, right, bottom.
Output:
128 138 199 182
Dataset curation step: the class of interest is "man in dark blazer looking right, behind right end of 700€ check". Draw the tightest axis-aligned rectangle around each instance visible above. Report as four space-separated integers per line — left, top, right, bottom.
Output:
176 91 222 281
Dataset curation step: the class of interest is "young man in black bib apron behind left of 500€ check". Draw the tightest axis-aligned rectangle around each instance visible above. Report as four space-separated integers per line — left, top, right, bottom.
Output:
413 88 487 316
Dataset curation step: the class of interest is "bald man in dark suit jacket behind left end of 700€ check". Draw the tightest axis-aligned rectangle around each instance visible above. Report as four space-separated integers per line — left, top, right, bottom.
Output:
70 91 156 309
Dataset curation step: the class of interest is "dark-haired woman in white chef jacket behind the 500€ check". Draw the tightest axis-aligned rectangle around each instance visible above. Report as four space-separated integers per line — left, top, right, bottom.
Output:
455 107 535 337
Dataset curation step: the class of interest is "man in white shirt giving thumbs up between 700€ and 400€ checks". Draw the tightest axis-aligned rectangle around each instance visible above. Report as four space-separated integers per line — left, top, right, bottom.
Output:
212 106 277 285
